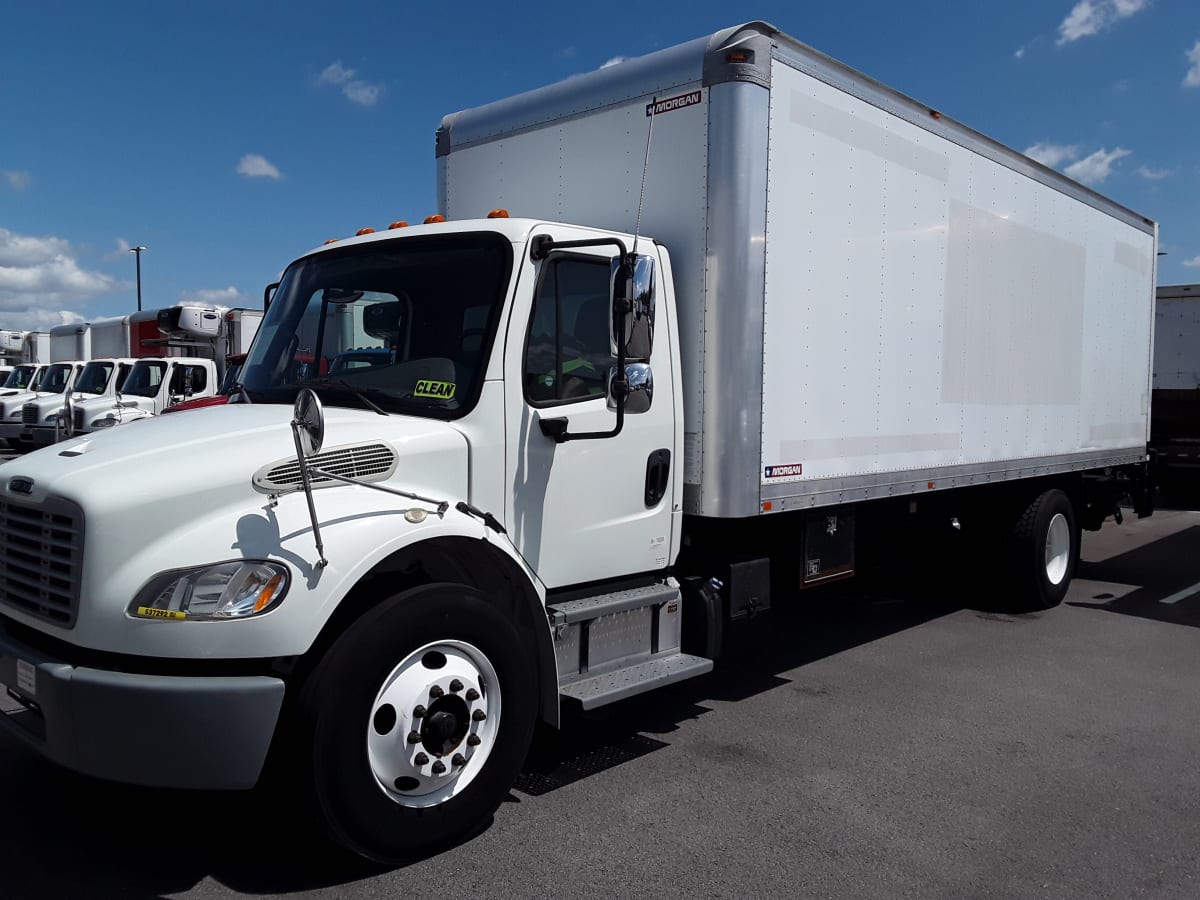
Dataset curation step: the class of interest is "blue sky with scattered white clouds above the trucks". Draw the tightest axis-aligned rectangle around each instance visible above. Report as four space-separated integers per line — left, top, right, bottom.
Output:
0 0 1200 329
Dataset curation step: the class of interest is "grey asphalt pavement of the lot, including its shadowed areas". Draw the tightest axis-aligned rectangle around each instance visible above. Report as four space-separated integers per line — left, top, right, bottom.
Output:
0 510 1200 900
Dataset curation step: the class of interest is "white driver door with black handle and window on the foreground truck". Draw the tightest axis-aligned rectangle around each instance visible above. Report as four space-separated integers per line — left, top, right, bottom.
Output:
505 229 677 588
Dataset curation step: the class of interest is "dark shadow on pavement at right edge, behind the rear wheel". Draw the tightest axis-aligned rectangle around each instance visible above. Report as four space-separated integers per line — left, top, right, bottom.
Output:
1068 526 1200 628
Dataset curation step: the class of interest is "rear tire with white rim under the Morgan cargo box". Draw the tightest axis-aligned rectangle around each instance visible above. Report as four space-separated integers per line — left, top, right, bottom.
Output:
1013 488 1080 610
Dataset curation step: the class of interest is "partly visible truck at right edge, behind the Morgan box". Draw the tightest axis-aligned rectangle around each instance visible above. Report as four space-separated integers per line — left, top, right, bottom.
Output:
1150 284 1200 493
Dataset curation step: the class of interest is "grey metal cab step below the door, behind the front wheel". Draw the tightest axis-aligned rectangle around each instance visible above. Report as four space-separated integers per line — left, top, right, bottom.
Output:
546 580 713 709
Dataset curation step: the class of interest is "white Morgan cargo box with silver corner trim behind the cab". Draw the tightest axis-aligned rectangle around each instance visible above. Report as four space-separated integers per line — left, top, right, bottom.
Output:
437 23 1157 516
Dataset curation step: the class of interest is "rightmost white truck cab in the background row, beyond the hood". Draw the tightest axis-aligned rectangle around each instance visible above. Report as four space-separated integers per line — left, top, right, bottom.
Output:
73 356 217 434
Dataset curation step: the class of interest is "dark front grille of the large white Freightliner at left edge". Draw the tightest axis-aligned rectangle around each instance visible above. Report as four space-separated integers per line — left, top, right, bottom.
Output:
0 497 83 628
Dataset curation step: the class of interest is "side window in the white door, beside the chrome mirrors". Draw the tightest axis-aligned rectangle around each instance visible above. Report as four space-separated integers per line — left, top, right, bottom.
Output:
524 256 617 404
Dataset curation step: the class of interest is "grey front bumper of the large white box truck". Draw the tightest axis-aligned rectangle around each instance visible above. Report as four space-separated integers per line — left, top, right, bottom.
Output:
0 624 283 790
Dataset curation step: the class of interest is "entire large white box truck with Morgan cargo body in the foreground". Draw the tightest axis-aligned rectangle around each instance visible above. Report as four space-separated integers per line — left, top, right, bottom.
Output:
0 23 1156 862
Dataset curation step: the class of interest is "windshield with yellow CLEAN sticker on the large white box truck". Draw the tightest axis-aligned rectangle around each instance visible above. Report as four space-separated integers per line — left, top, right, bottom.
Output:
241 233 512 419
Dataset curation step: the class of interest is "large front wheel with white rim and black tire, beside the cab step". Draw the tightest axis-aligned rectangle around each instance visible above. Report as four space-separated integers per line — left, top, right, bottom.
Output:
301 584 538 864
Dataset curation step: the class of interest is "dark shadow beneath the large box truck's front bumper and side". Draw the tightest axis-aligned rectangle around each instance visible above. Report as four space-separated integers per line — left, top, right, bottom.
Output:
0 573 962 900
